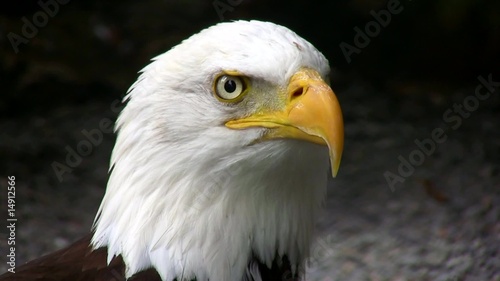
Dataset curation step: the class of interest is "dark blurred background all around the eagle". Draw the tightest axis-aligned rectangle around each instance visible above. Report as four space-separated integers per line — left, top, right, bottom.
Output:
0 0 500 280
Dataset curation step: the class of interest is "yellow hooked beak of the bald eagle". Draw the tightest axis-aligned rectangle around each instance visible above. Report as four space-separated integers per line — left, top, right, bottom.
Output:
225 68 344 177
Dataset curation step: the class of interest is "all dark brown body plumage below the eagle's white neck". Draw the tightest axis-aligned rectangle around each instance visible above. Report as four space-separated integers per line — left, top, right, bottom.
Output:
0 235 296 281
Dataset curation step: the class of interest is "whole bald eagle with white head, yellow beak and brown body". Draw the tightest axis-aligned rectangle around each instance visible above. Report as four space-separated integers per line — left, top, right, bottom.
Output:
0 21 343 281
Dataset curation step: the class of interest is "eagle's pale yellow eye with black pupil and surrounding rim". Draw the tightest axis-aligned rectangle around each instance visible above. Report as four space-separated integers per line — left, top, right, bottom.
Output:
214 74 247 102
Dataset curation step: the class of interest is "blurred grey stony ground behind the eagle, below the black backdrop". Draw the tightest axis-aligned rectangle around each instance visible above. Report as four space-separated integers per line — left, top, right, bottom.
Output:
0 75 500 281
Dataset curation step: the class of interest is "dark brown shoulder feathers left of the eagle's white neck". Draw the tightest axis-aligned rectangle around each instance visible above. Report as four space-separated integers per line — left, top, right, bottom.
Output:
0 234 161 281
